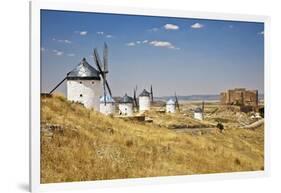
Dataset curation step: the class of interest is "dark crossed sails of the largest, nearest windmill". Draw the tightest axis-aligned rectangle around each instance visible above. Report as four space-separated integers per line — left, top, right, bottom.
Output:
94 43 112 105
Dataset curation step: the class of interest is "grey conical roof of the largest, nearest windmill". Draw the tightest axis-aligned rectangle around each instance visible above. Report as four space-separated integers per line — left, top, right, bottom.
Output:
67 58 100 80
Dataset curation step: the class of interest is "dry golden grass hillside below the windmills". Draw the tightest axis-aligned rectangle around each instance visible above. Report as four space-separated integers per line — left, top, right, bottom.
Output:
41 95 264 183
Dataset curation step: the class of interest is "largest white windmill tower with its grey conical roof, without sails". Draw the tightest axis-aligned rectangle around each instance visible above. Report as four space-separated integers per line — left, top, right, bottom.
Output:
66 58 101 111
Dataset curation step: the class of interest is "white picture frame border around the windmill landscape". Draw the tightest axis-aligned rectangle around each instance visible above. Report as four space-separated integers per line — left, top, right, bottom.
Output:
30 0 270 192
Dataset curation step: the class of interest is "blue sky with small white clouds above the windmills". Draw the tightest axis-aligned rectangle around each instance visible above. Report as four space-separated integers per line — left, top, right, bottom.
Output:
41 10 264 96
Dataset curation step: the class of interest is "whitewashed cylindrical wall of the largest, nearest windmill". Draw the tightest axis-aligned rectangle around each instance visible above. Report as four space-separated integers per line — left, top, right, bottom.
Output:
67 80 101 111
